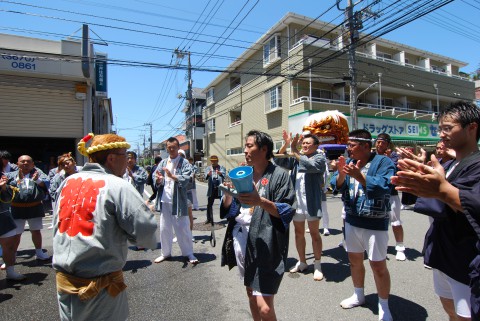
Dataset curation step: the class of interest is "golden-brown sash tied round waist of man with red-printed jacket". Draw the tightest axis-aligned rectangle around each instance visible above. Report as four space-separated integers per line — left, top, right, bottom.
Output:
56 271 127 301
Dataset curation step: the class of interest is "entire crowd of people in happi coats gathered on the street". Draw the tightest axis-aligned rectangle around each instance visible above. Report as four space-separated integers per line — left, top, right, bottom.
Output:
0 102 480 321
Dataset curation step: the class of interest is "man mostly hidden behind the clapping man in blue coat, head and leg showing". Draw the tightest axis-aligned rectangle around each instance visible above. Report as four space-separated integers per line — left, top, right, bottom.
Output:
375 133 407 261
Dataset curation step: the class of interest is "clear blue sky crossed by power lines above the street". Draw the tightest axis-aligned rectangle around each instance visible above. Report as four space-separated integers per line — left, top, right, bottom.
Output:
0 0 480 149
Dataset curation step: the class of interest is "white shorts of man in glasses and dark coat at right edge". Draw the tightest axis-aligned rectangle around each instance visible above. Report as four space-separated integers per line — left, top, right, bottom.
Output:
433 269 471 318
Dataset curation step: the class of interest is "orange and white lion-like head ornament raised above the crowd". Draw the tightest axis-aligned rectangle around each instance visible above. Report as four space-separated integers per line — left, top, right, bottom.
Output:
303 110 349 145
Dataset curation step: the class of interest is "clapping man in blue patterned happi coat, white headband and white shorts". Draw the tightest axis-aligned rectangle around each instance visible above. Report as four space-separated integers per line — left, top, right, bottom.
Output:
336 129 395 321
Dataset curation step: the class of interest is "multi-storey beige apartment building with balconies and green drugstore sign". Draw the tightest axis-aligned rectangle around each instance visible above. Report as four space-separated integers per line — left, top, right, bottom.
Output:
203 13 475 169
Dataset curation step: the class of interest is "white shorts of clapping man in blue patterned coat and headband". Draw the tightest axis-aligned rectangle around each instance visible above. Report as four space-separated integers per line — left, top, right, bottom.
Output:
345 223 388 261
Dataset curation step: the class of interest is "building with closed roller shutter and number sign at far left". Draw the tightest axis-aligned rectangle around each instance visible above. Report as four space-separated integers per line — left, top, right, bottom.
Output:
0 34 112 169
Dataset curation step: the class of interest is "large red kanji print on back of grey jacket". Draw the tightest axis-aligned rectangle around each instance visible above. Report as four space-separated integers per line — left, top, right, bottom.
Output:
58 177 105 236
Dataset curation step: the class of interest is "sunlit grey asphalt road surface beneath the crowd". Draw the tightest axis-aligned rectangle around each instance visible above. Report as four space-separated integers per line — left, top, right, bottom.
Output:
0 184 446 321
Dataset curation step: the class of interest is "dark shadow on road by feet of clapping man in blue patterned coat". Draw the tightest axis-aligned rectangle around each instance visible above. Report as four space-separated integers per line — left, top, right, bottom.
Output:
363 294 428 321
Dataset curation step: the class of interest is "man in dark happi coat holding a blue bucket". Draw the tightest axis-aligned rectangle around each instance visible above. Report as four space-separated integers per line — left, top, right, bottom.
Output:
220 130 295 320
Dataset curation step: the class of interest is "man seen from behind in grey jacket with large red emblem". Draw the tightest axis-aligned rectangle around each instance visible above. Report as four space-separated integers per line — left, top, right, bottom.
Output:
53 134 157 320
